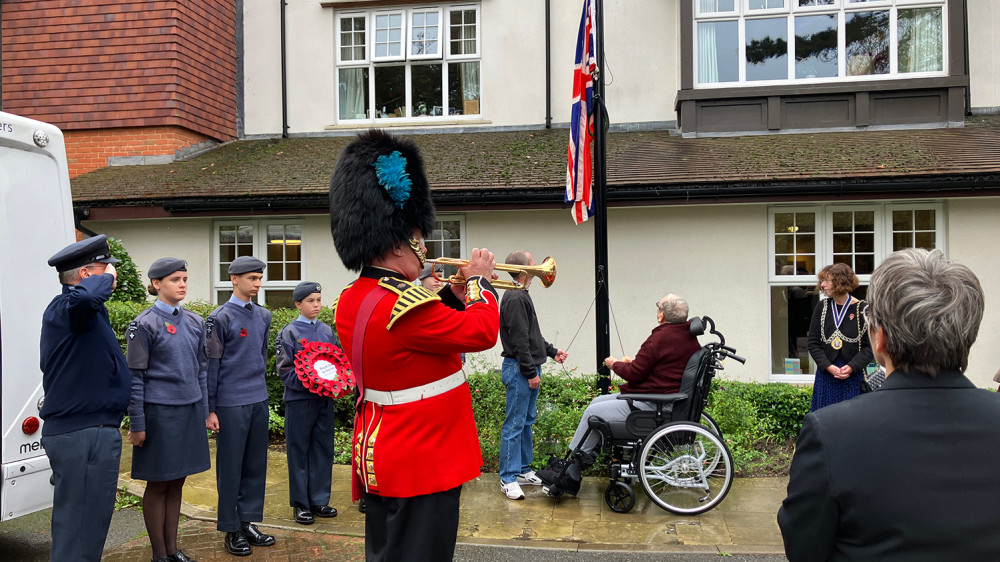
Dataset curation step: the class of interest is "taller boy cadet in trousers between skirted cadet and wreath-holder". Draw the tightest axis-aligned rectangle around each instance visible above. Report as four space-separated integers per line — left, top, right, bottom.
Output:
205 256 274 556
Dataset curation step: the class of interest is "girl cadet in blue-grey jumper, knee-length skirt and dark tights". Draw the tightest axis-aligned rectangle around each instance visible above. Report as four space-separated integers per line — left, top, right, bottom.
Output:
125 258 212 562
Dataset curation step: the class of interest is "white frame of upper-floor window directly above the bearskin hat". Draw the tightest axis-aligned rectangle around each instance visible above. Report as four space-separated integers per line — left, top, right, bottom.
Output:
333 2 483 126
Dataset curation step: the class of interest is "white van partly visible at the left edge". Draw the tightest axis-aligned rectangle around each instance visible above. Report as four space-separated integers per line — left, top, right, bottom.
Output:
0 112 76 521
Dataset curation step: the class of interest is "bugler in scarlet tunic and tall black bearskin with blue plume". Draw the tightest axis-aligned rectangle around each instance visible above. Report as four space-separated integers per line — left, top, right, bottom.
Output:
330 130 499 561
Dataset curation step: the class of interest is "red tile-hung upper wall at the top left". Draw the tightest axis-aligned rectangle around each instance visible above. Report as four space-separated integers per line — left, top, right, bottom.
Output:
0 0 236 144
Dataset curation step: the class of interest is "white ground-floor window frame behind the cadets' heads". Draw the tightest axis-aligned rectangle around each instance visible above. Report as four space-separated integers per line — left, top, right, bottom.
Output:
212 216 308 306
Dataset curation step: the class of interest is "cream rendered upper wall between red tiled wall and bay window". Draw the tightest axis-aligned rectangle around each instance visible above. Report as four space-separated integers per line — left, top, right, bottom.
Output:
243 0 680 135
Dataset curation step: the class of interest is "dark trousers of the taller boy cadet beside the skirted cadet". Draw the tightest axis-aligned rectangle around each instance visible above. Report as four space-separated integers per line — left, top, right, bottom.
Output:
215 400 268 532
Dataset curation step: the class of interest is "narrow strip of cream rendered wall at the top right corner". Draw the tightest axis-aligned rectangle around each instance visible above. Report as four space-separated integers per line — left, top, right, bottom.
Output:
966 0 1000 109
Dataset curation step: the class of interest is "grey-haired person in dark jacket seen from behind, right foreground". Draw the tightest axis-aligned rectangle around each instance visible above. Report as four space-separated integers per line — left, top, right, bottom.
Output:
778 249 1000 562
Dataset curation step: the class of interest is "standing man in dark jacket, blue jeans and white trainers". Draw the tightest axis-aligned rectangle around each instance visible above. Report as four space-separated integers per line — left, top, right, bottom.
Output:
500 250 566 500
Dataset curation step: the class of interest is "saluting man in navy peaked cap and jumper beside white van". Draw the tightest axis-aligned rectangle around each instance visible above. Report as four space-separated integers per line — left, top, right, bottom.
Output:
40 234 131 561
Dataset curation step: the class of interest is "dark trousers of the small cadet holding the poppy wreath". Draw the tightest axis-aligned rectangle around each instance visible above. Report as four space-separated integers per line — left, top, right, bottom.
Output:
285 398 333 509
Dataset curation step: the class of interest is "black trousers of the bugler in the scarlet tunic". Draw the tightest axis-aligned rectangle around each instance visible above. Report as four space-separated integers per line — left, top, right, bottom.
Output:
365 486 462 562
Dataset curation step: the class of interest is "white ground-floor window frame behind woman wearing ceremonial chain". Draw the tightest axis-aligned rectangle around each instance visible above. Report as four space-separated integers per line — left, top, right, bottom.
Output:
764 200 948 383
